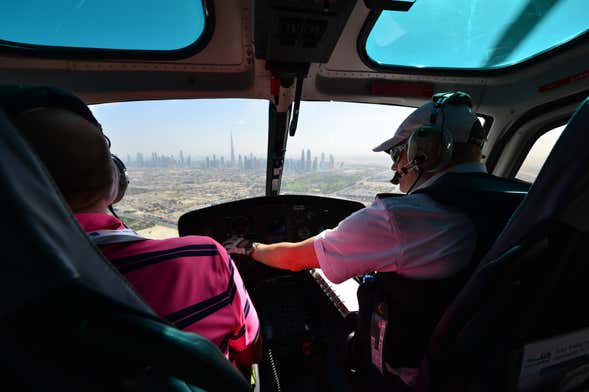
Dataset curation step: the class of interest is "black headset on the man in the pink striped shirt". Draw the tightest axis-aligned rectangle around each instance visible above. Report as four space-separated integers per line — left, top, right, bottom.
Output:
0 86 129 207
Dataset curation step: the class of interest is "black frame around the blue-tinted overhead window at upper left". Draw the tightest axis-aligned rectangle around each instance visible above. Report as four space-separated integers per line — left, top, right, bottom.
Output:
0 0 215 60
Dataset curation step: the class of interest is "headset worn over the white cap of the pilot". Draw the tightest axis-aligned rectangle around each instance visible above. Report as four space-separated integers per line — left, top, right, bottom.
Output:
405 91 485 173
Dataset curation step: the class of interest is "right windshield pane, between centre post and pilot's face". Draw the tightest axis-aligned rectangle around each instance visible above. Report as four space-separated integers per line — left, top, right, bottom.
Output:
281 102 414 204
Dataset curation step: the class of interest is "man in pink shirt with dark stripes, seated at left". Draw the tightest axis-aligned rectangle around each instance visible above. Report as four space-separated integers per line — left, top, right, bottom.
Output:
8 88 261 368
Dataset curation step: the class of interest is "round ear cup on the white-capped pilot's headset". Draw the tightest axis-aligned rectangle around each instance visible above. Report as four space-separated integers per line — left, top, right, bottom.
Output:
407 125 454 172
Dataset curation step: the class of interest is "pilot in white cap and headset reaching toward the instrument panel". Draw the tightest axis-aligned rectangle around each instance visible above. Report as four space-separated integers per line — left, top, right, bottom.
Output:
225 92 527 388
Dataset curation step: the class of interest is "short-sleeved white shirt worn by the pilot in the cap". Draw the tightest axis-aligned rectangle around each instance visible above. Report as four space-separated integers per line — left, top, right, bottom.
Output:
313 163 486 283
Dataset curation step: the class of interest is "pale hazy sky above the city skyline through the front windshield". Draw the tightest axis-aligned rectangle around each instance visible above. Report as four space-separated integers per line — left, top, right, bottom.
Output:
91 99 414 160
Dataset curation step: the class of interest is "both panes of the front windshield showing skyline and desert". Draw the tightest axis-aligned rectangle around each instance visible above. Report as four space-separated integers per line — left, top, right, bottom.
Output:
91 99 414 237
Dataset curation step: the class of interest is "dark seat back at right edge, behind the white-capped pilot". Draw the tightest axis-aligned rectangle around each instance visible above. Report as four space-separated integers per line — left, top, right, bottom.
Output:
417 100 589 392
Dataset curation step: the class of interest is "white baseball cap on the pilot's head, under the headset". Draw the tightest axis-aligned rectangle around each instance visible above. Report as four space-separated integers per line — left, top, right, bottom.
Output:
372 101 478 152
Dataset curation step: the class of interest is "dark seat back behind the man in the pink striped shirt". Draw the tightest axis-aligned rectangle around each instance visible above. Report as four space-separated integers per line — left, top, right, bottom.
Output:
0 106 251 391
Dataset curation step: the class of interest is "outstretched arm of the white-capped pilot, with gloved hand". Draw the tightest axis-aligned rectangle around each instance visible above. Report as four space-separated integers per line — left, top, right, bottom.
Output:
228 199 400 283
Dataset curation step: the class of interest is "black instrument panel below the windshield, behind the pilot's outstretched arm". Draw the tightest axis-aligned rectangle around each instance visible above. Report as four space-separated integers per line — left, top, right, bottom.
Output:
178 195 364 243
